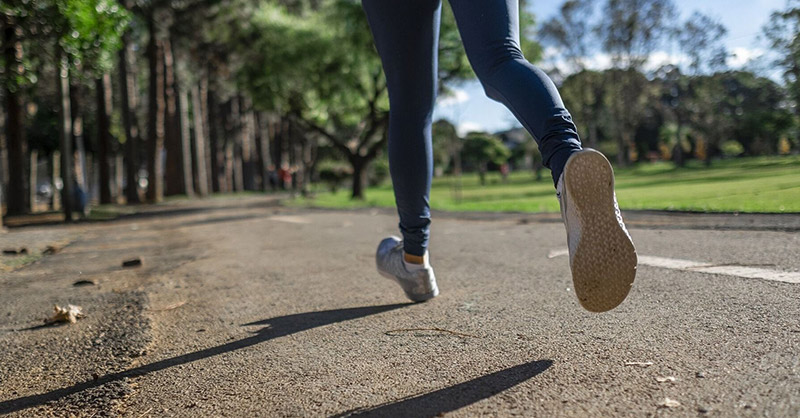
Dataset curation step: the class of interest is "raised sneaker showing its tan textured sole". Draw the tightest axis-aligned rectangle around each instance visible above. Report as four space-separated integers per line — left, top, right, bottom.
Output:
556 148 638 312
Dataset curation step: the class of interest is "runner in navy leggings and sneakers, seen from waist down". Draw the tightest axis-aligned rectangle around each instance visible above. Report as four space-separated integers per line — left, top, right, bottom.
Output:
362 0 637 312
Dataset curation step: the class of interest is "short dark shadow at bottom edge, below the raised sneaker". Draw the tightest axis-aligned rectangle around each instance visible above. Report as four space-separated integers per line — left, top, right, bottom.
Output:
331 360 553 418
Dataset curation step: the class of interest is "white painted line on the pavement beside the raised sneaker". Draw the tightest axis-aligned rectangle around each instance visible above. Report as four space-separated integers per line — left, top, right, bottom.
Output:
547 250 800 284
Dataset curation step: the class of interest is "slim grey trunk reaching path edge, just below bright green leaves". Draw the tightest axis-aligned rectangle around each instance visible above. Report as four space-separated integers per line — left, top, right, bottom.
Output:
56 51 74 222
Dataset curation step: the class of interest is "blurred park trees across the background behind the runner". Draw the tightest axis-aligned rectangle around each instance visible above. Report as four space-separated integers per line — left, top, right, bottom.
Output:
0 0 800 219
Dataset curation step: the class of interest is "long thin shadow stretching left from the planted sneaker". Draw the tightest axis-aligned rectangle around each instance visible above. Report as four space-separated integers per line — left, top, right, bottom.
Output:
0 303 412 414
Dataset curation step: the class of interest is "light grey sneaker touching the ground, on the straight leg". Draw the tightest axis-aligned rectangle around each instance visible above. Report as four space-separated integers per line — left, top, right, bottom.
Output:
375 237 439 302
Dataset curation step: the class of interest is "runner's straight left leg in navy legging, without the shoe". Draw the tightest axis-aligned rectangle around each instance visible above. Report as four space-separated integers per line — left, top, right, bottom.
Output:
362 0 441 256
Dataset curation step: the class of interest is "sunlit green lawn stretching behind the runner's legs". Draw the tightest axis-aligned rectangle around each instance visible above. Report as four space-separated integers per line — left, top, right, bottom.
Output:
289 155 800 213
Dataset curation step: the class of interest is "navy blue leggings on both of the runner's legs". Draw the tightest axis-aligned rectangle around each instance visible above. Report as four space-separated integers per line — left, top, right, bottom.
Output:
362 0 581 256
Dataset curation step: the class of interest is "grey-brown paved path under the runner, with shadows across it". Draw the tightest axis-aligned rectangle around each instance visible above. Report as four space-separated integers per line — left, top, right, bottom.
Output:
0 198 800 417
